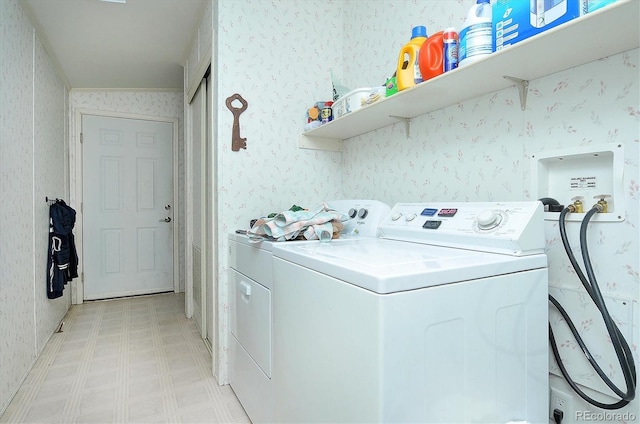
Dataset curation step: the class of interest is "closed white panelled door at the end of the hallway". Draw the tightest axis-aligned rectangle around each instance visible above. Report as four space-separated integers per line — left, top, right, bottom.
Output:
82 115 175 300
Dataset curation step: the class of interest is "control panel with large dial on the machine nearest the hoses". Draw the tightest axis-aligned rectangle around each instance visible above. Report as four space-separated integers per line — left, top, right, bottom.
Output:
380 201 545 256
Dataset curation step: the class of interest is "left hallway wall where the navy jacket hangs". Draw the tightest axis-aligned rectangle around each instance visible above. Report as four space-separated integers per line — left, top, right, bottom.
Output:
0 0 73 412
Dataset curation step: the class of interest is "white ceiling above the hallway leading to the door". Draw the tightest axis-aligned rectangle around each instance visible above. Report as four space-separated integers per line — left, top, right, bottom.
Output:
21 0 206 90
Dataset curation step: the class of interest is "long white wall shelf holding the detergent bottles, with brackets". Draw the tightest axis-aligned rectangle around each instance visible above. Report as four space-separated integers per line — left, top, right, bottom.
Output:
298 0 640 150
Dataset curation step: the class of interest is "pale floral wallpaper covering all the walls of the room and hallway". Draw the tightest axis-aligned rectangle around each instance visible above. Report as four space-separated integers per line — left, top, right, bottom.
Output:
0 0 640 422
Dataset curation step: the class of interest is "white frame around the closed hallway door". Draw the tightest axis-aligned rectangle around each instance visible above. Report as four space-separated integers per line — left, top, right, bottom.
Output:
71 109 180 304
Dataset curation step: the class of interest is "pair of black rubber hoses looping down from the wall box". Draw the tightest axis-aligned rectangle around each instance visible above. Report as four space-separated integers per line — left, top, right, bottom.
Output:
549 207 636 409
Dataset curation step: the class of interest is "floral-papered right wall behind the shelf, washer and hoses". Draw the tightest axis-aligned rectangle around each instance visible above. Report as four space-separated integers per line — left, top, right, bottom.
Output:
342 0 640 423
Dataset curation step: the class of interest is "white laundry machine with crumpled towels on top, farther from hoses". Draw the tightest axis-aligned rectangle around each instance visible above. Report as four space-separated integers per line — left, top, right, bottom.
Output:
229 199 390 423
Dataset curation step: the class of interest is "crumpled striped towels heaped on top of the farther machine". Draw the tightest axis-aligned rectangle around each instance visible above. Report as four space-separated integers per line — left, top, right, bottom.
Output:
247 205 349 241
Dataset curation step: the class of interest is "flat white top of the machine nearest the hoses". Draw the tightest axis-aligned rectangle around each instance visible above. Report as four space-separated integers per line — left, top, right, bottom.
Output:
273 238 547 294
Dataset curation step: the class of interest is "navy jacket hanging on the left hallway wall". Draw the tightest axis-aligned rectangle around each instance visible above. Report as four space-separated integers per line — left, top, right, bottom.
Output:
47 199 78 299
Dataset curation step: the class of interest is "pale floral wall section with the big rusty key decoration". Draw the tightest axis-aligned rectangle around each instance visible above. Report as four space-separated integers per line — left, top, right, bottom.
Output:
214 0 343 383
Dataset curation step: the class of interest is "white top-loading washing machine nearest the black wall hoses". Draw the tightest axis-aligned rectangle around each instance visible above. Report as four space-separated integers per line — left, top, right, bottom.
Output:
273 202 548 423
